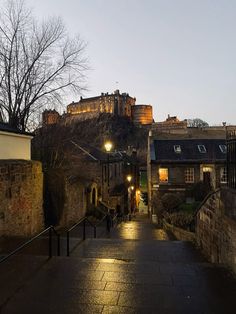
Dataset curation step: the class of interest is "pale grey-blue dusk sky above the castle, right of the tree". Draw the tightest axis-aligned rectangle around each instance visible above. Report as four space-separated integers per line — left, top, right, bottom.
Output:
10 0 236 125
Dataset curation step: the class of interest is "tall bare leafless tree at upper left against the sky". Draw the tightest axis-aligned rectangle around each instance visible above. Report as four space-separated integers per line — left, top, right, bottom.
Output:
0 0 88 131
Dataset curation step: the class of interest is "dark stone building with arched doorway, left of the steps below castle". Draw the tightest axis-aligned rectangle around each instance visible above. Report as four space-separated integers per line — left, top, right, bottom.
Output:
42 140 129 228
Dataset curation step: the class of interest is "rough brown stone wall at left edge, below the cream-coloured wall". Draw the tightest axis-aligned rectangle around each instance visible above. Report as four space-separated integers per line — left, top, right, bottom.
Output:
0 160 44 236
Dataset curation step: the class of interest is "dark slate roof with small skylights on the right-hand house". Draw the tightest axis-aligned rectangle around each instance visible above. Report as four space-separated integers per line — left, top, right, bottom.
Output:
151 139 226 163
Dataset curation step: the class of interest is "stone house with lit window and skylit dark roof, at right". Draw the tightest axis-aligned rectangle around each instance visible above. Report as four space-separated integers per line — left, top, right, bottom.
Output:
147 131 227 212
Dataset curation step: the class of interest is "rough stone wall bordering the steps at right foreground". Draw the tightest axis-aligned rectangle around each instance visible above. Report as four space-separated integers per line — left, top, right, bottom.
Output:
196 189 236 273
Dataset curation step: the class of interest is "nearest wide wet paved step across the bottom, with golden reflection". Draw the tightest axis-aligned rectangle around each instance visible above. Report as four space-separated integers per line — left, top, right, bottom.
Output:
0 256 236 314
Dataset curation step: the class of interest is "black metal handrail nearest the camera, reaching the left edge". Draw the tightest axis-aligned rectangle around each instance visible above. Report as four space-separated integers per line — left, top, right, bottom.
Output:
0 226 60 263
